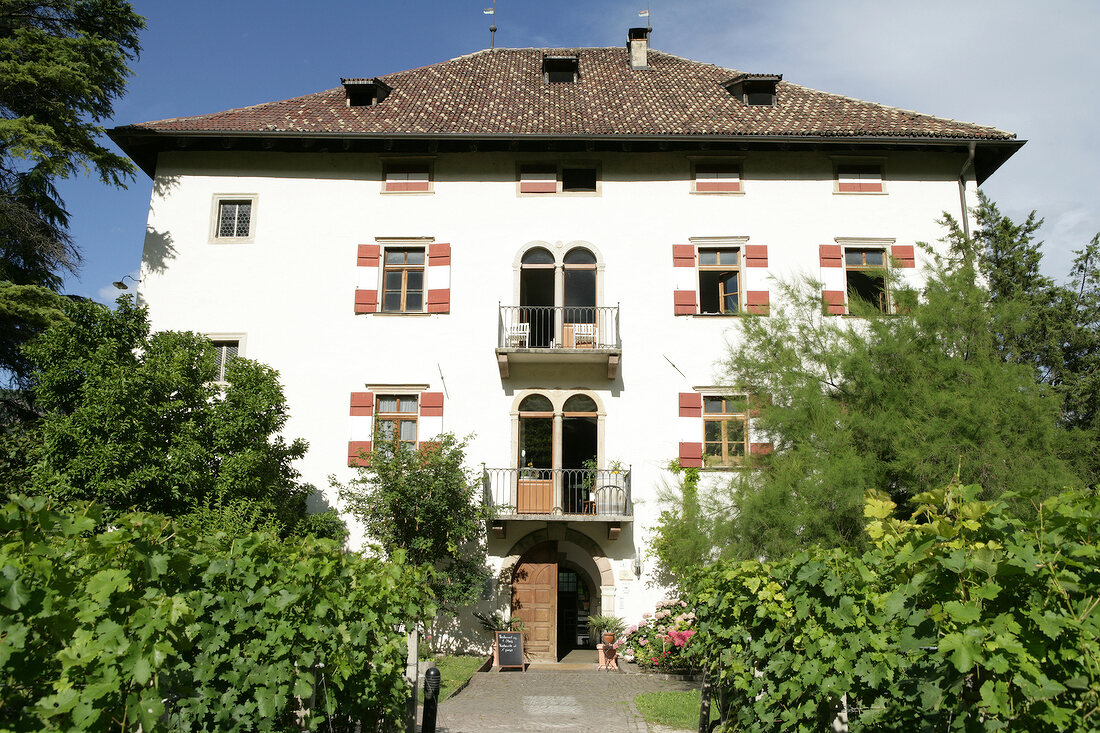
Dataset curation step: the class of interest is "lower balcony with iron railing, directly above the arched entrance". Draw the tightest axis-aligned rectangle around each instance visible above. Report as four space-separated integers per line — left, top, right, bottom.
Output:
482 468 634 539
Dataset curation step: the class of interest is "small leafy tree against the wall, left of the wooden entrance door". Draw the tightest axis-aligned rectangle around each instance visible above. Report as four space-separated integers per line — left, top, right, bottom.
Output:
333 433 490 612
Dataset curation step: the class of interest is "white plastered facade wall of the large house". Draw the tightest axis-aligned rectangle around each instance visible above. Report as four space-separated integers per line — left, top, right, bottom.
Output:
139 147 974 620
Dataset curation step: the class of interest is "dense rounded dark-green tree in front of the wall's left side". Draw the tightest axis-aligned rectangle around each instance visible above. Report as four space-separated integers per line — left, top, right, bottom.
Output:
19 296 339 534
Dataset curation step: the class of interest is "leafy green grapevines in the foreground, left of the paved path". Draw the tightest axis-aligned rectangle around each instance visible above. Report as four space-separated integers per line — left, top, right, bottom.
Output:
0 497 435 731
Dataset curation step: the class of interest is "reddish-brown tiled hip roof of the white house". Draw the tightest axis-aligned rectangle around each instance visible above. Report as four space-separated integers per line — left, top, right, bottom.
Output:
119 48 1015 141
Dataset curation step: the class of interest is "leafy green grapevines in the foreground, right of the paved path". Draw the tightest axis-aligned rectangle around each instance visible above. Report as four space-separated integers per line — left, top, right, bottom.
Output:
694 485 1100 731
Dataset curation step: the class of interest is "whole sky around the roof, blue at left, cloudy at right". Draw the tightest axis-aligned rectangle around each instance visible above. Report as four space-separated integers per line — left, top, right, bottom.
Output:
61 0 1100 300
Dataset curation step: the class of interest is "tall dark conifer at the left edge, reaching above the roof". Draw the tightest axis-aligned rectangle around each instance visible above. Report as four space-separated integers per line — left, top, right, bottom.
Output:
0 0 145 383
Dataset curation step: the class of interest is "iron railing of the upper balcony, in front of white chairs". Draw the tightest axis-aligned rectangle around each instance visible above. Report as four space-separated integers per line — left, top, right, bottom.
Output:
497 305 623 350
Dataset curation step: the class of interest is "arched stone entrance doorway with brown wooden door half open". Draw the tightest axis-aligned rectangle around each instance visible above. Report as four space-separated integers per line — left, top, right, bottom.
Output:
512 540 603 661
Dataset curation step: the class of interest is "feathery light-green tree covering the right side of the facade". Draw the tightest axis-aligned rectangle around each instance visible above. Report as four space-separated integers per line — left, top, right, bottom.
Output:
655 205 1081 558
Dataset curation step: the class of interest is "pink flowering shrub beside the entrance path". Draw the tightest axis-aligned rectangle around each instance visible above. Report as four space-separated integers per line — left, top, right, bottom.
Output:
615 600 699 672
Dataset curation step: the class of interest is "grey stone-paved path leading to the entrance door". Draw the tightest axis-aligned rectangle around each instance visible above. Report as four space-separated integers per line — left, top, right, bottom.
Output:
426 669 699 733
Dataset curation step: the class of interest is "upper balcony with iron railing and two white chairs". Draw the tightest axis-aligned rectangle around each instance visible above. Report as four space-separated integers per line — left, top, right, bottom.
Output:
496 305 623 380
